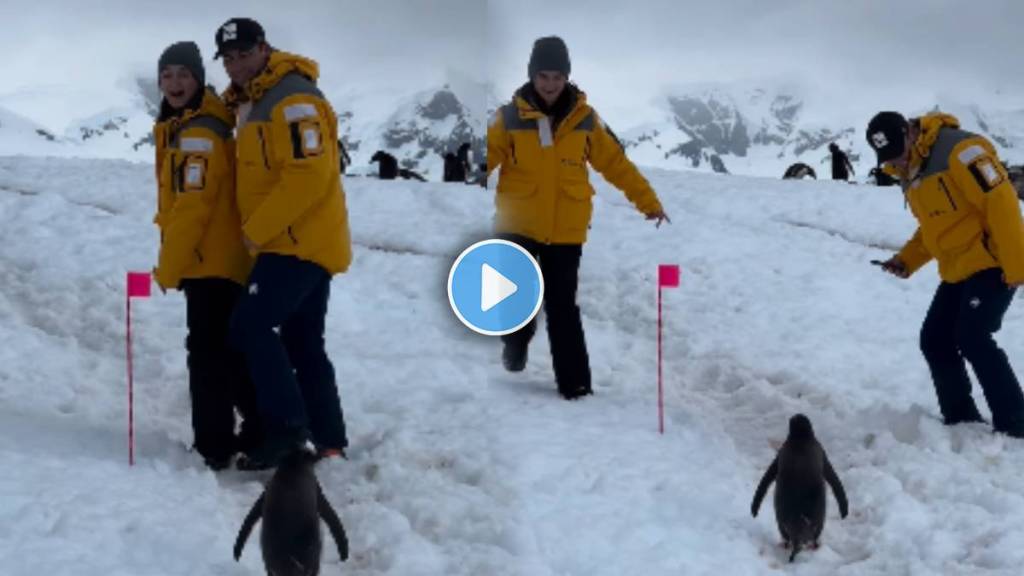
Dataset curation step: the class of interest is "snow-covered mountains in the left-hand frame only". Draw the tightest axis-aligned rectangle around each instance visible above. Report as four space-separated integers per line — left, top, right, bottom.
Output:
0 75 485 180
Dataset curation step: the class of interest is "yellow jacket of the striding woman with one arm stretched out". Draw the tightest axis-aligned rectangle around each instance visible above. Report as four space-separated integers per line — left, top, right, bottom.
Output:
487 84 662 244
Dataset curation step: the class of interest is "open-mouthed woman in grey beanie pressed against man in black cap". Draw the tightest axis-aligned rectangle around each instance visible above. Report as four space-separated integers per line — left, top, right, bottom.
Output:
154 42 261 469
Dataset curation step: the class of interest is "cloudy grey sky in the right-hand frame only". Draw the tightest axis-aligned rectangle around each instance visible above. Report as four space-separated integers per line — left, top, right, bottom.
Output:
487 0 1024 124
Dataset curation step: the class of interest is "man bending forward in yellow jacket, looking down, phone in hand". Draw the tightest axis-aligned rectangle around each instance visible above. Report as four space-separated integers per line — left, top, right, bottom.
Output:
866 112 1024 438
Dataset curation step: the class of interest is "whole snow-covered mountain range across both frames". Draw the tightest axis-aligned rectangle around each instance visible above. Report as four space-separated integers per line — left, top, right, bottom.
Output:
8 74 1024 180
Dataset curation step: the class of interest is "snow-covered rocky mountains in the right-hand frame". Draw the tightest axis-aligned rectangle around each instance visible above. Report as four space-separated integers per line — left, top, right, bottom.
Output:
622 84 1024 177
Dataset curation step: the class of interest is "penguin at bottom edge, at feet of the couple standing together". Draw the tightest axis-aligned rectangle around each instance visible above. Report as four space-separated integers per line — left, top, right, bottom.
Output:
234 445 348 576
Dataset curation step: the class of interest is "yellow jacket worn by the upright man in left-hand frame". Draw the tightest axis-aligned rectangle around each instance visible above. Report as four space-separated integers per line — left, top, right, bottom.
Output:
224 51 352 274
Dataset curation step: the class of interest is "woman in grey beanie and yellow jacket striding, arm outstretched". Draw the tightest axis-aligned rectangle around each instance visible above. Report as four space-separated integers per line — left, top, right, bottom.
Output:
487 36 668 393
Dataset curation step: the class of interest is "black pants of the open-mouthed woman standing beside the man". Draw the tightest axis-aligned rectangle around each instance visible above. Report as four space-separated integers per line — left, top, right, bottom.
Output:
181 278 262 460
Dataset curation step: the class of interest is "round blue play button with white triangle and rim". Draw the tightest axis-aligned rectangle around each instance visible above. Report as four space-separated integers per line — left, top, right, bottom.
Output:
449 240 544 336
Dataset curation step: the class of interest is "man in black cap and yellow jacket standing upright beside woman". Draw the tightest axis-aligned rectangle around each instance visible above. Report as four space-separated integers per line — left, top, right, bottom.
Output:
216 18 351 469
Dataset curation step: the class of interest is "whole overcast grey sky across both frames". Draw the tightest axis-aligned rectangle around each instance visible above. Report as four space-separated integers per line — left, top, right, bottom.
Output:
0 0 1024 132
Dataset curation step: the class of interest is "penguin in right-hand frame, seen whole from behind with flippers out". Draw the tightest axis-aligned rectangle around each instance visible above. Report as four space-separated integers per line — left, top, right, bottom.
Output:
751 414 849 562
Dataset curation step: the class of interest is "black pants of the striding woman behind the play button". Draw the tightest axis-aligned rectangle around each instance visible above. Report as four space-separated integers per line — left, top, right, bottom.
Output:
502 236 591 395
